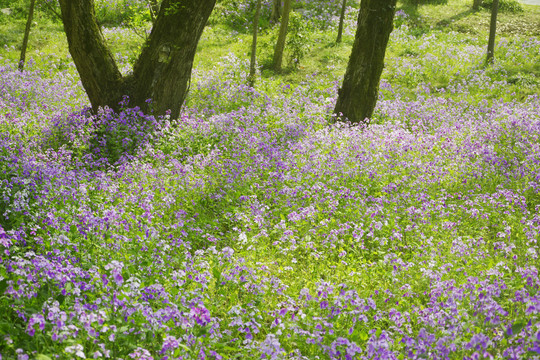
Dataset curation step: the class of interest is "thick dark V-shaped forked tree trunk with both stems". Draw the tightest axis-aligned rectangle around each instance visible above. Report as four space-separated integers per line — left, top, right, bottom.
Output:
56 0 216 118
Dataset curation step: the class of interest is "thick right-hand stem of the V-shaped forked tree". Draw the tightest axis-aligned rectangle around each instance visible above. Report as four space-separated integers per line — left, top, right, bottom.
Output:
132 0 216 118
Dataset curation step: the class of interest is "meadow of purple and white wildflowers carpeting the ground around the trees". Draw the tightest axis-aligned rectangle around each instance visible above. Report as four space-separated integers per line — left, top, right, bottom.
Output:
0 2 540 360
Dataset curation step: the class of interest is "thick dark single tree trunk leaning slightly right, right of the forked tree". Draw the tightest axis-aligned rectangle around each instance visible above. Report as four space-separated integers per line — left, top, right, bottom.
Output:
334 0 397 123
